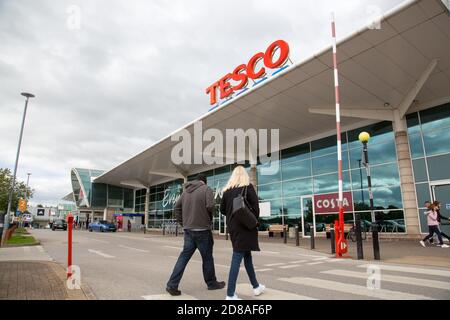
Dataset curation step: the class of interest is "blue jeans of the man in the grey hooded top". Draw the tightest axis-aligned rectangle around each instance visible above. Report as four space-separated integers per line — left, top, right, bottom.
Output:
167 230 217 289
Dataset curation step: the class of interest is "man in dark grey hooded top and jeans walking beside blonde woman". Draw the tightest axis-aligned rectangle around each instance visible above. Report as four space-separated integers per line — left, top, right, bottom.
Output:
166 174 225 296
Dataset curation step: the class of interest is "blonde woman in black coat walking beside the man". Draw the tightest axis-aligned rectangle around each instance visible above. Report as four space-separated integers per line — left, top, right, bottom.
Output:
220 166 265 300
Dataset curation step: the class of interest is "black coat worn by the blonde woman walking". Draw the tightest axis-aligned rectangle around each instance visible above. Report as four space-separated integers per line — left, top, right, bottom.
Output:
220 184 260 251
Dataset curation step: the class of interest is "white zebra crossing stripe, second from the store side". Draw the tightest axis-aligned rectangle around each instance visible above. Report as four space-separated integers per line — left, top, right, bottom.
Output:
321 270 450 290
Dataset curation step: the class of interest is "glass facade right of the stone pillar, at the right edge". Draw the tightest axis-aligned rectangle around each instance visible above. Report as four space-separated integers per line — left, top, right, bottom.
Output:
407 103 450 234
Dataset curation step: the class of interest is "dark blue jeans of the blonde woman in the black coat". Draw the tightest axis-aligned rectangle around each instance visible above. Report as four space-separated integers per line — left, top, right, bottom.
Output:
227 251 259 297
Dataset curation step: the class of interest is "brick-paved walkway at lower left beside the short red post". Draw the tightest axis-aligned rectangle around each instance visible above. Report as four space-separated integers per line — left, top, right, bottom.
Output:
0 246 95 300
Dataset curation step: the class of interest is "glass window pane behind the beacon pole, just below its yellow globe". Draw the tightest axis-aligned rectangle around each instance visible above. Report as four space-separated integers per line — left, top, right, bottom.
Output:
350 141 397 168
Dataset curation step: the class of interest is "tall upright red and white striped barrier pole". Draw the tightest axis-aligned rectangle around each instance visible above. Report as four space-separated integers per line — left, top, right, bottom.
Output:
331 13 347 257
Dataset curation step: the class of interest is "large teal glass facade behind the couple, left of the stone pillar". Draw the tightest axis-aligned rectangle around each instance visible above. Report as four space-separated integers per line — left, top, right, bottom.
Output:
135 122 404 231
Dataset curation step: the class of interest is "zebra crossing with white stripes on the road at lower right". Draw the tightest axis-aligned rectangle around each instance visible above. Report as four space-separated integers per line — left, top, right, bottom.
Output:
143 257 450 300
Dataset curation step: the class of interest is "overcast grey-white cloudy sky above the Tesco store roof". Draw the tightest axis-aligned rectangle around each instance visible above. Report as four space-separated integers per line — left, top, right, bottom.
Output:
0 0 402 204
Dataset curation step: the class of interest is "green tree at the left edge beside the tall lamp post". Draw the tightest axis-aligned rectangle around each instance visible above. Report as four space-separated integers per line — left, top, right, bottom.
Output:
0 168 34 213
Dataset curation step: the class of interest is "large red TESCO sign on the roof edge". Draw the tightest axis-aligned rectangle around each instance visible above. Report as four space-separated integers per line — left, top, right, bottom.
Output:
206 40 289 105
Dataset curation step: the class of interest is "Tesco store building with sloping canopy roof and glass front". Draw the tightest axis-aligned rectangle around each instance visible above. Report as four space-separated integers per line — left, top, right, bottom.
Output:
93 0 450 238
